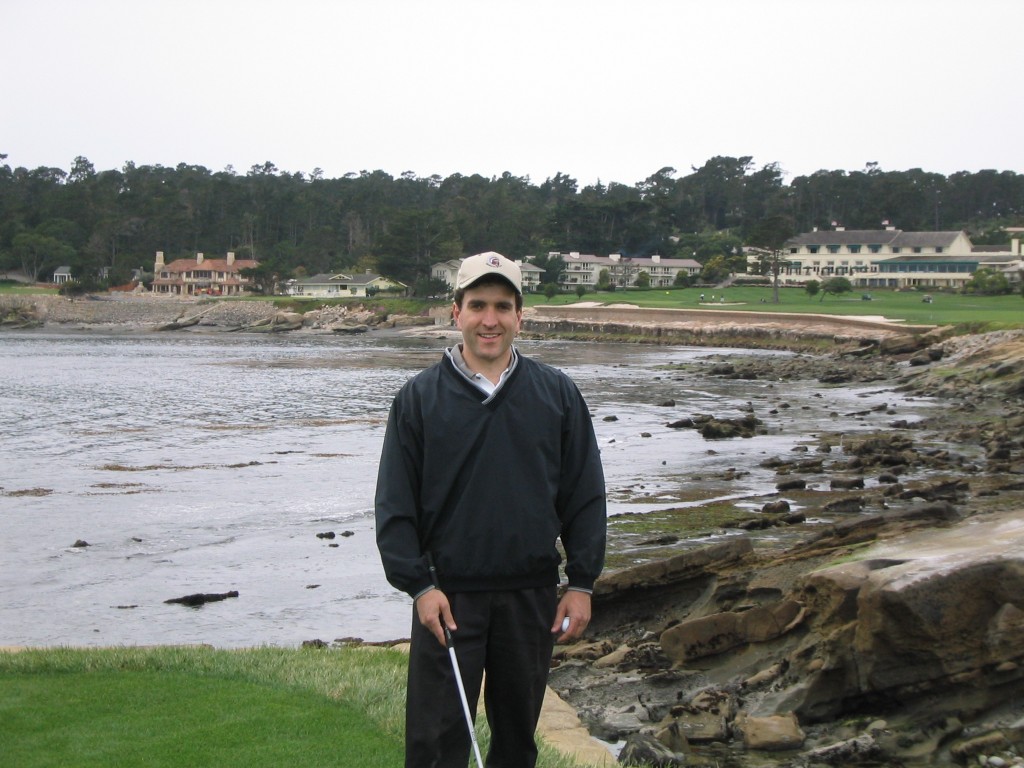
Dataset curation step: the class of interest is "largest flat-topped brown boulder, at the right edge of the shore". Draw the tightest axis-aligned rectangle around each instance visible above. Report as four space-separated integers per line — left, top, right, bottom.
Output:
765 517 1024 720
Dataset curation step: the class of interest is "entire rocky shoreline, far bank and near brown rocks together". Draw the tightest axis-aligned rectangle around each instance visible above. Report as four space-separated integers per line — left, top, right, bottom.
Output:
6 296 1024 768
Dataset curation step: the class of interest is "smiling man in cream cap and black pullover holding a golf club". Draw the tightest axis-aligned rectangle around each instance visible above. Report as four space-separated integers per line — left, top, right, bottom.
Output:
376 252 606 768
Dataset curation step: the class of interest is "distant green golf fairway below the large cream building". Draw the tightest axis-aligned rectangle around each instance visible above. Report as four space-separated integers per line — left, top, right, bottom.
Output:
526 287 1024 331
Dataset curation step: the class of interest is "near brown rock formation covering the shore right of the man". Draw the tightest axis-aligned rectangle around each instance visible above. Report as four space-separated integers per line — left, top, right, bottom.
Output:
551 332 1024 767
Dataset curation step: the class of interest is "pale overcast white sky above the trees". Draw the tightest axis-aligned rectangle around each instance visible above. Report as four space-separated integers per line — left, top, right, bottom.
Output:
0 0 1024 187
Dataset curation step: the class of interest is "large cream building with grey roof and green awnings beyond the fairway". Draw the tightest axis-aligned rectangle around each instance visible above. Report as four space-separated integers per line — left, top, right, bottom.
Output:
778 225 1020 289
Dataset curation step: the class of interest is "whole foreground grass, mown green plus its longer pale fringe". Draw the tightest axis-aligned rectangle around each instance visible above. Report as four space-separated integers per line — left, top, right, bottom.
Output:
0 646 593 768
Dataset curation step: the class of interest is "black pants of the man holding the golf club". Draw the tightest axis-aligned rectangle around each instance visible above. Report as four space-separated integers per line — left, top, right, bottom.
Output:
406 587 557 768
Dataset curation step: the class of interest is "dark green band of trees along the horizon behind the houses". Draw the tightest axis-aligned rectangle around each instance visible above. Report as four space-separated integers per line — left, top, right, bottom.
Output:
0 155 1024 291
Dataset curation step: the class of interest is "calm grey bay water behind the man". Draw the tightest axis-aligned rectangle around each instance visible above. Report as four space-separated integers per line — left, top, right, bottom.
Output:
0 332 929 647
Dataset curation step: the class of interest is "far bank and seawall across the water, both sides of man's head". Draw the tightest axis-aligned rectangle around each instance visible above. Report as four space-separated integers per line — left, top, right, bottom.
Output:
0 294 951 353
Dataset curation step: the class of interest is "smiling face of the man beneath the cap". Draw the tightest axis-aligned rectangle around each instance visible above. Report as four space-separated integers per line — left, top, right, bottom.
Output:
453 284 522 370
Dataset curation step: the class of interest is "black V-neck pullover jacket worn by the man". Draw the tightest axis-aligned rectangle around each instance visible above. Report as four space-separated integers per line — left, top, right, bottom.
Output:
375 354 607 597
